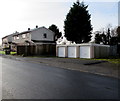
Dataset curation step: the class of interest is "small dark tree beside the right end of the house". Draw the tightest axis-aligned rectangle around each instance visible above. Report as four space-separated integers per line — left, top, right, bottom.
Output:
49 24 62 41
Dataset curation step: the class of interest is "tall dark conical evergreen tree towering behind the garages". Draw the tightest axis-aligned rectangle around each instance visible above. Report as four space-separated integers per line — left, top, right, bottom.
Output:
64 1 92 43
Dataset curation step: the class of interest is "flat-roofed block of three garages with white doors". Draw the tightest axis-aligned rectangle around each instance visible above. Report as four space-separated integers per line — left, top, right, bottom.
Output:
56 43 110 58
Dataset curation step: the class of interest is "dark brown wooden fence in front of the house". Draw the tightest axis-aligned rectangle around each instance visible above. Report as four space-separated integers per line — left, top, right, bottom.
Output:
17 44 56 56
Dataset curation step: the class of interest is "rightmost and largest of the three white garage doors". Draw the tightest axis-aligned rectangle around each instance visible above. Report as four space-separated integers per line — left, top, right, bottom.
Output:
80 46 90 58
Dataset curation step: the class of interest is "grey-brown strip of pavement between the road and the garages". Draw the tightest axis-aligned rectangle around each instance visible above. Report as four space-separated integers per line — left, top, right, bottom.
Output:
3 55 120 79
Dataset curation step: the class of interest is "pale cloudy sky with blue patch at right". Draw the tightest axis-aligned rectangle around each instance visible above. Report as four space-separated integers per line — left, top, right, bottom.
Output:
0 0 119 43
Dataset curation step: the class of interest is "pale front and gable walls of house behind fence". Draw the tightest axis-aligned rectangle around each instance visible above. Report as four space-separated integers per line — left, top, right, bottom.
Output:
12 27 54 44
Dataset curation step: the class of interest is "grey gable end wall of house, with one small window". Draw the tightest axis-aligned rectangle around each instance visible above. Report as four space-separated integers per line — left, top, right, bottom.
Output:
30 27 54 41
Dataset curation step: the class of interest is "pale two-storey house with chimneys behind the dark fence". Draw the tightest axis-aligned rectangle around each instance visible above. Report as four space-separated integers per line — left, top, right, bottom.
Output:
12 26 55 45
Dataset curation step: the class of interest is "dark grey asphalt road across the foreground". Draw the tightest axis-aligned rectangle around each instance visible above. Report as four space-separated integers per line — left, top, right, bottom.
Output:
0 57 119 99
